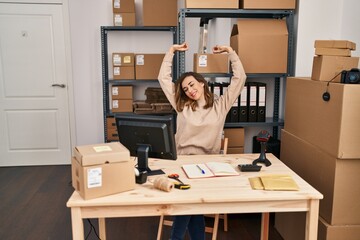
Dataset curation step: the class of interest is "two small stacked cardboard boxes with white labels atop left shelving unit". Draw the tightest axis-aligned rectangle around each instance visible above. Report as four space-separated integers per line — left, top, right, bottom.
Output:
113 0 136 26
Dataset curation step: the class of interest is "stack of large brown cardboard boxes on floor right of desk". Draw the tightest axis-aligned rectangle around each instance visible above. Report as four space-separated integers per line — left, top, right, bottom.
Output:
275 40 360 240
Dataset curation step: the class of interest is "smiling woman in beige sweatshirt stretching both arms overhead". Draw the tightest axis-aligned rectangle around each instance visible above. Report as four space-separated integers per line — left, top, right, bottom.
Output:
158 43 246 240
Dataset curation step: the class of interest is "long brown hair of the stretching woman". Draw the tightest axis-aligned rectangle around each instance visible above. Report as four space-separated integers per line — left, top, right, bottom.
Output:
175 72 214 112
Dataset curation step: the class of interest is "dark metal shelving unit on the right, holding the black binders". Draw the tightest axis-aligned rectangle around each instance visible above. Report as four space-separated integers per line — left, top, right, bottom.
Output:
177 8 294 139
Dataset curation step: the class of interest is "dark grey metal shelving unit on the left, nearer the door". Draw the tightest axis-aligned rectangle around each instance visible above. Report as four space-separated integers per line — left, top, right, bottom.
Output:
100 26 178 142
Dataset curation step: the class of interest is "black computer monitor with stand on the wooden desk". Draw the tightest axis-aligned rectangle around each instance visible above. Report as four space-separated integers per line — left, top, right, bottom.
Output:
115 114 177 175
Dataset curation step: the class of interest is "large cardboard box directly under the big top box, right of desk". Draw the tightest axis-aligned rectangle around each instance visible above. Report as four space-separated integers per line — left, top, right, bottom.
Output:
281 129 360 225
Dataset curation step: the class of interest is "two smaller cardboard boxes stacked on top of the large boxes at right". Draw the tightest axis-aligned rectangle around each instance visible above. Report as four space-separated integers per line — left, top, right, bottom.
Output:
311 40 359 82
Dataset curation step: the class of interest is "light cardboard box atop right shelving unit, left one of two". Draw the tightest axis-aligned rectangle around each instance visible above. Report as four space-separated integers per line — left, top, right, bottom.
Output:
185 0 239 9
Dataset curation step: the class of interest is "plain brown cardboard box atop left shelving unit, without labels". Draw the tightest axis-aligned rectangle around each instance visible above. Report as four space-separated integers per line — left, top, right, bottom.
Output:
143 0 178 26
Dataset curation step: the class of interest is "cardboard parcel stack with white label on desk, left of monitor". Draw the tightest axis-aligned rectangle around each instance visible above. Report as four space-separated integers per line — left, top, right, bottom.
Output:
71 142 135 200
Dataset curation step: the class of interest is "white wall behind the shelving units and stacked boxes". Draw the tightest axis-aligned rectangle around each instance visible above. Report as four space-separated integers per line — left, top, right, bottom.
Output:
69 0 360 152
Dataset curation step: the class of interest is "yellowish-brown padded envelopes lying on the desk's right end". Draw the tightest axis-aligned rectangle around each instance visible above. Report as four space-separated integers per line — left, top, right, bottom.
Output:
249 174 299 191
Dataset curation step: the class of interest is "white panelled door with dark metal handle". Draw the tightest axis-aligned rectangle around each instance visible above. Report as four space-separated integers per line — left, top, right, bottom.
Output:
0 3 71 166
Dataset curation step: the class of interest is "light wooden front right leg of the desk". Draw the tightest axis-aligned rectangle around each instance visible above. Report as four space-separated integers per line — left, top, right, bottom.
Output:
305 199 319 240
